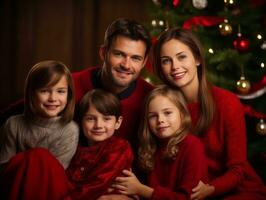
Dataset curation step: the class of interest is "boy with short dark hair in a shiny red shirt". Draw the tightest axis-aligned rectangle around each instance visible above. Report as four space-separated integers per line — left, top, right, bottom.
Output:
66 89 133 200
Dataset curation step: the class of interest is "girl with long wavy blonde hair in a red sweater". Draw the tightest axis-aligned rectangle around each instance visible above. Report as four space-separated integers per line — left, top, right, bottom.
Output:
112 85 207 200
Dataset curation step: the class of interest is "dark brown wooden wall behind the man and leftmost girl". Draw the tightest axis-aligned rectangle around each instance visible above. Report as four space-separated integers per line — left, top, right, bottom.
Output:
0 0 149 107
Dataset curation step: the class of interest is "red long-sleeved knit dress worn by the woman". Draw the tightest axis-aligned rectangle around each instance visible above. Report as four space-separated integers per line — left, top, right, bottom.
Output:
188 87 266 200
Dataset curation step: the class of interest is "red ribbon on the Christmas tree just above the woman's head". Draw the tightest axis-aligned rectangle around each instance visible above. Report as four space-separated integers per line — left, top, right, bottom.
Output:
183 16 224 29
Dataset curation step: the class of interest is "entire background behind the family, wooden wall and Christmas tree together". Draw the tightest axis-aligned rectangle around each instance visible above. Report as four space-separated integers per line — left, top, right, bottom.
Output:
0 0 266 182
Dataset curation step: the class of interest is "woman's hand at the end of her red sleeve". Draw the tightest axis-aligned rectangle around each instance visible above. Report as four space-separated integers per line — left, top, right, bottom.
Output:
191 181 215 200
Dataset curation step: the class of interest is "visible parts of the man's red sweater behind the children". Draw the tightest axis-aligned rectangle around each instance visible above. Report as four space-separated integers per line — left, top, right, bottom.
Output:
73 67 153 144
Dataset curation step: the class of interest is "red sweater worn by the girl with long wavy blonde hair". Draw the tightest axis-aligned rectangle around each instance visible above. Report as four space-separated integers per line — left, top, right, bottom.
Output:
148 135 207 200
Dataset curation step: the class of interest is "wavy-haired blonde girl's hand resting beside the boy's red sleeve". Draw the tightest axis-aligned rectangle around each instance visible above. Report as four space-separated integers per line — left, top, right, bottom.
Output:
112 170 142 195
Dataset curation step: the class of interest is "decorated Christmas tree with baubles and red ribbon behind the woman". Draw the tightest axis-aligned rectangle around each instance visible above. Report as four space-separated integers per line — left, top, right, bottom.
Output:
144 0 266 181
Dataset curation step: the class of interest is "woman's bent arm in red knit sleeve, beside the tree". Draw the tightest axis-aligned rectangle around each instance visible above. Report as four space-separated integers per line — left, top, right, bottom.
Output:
210 95 247 195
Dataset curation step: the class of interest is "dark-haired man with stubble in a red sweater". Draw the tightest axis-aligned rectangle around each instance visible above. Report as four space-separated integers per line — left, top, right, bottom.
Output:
73 19 152 145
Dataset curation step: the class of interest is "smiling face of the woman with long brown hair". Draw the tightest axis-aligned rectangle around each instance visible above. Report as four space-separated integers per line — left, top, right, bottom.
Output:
160 39 200 90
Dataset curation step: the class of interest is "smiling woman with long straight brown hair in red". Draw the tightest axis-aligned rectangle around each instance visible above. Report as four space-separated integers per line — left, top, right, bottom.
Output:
154 28 266 200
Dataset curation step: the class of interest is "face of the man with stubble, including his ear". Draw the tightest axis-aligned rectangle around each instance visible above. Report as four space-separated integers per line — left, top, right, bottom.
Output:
101 36 146 93
